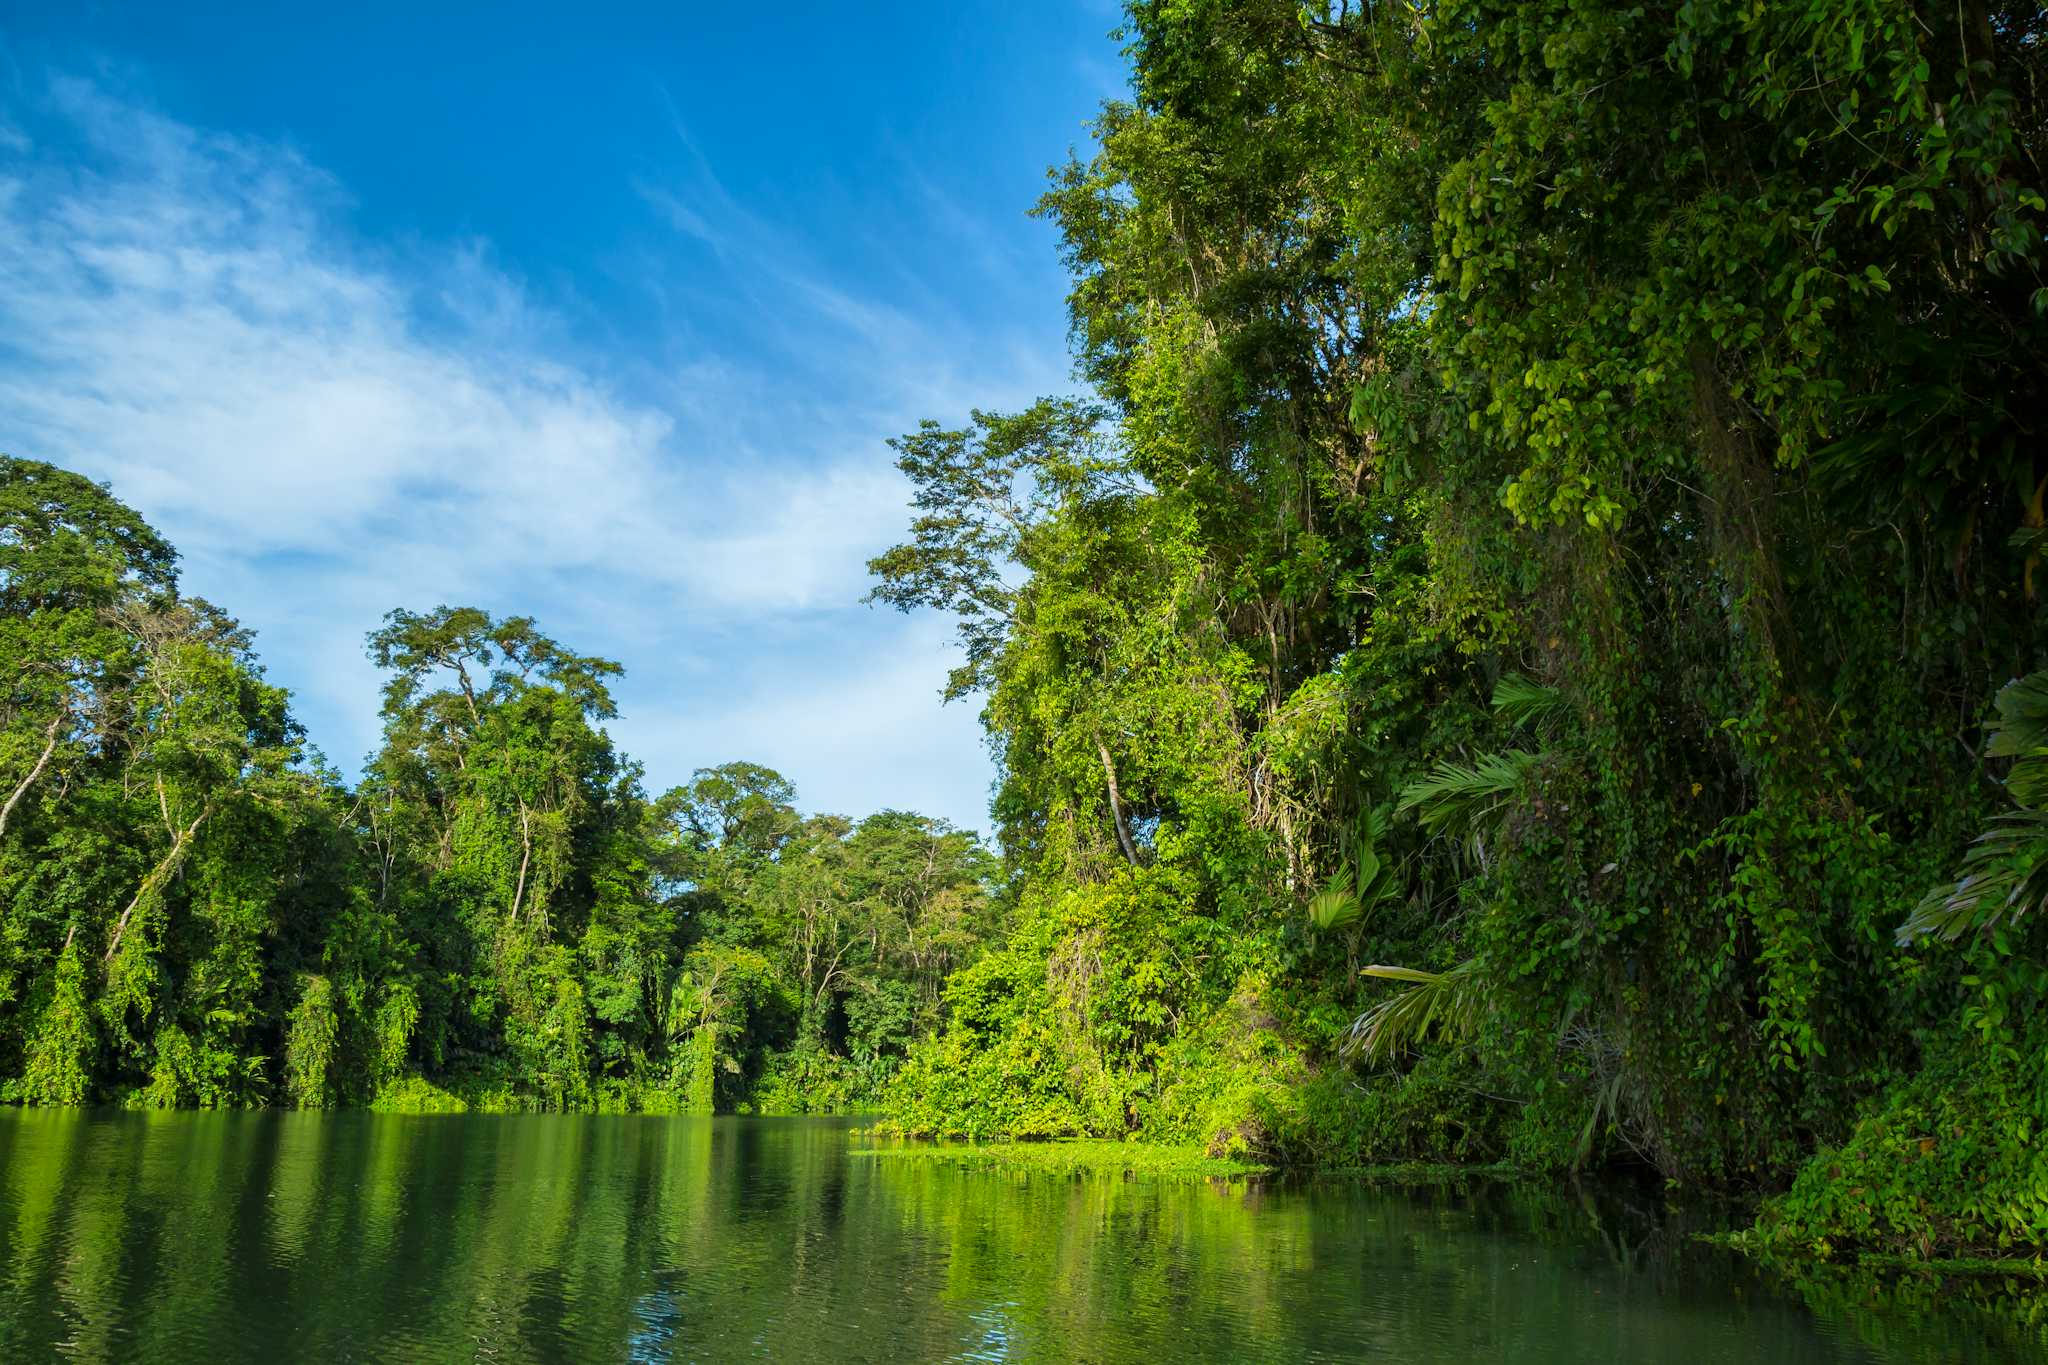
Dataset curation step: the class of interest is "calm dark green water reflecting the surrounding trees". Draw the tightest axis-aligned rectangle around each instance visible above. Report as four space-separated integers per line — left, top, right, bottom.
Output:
0 1111 2048 1363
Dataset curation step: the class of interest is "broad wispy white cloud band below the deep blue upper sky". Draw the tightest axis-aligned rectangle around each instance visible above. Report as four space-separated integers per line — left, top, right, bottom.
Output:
0 78 1063 823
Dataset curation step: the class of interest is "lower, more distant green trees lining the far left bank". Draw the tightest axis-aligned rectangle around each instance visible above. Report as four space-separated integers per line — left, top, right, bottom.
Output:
0 458 999 1111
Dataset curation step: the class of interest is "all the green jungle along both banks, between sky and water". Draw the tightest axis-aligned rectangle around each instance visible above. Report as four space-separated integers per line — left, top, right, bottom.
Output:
0 0 2048 1254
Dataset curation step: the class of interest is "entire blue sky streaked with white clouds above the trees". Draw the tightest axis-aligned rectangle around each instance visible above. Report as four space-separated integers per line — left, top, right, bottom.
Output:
0 0 1122 825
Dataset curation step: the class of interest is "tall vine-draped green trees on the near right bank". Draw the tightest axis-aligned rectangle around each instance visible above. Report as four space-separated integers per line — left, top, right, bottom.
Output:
872 0 2048 1252
